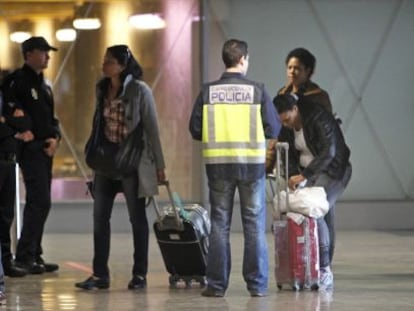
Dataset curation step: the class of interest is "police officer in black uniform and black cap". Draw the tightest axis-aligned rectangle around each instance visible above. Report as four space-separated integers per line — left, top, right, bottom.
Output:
3 37 60 274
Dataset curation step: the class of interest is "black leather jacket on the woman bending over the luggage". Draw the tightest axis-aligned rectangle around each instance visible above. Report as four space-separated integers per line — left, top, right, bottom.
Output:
279 102 350 179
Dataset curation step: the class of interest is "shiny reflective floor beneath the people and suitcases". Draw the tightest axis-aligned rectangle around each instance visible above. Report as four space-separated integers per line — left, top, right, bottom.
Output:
0 231 414 311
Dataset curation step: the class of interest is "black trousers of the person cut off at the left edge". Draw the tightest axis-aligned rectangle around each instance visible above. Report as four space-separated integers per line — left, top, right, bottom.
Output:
0 160 16 264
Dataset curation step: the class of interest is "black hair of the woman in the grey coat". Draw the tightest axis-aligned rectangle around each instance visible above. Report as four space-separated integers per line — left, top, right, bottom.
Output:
106 44 143 81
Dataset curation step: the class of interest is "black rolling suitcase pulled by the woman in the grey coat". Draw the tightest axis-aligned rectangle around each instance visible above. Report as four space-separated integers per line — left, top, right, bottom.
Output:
152 181 210 287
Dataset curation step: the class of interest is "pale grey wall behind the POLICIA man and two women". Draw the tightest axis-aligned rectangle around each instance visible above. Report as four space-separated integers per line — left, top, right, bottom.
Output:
204 0 414 201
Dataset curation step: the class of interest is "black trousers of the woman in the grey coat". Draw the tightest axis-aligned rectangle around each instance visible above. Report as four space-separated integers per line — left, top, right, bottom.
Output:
93 174 149 278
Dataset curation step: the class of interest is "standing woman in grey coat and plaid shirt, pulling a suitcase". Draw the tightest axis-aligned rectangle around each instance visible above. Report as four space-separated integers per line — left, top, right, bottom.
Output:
75 45 165 289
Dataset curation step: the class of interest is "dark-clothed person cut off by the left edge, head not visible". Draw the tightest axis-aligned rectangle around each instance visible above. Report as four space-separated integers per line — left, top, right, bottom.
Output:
0 92 32 278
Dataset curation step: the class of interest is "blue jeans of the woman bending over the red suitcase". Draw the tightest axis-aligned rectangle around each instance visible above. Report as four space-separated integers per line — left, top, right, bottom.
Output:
306 164 352 267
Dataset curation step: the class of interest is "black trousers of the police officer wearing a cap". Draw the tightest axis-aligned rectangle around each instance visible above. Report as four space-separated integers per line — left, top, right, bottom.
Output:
16 141 53 262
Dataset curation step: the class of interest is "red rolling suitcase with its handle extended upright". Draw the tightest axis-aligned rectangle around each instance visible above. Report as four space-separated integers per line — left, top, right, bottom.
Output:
273 143 319 290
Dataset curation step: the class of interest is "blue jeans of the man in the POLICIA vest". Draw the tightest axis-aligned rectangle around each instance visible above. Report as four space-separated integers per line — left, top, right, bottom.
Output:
206 176 269 293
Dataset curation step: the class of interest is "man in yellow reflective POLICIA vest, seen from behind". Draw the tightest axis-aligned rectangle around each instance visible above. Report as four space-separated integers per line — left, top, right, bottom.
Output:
190 39 281 297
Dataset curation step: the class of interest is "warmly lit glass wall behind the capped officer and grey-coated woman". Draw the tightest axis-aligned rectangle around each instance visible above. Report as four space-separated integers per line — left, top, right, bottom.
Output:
0 0 200 200
